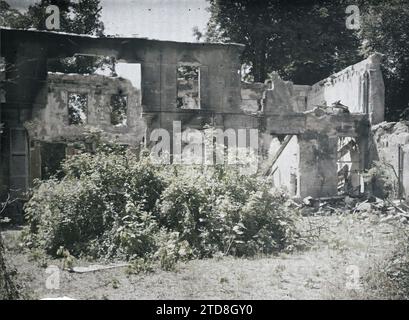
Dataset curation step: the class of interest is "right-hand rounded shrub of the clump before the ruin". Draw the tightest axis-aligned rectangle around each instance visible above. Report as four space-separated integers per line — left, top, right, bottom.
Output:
159 167 295 257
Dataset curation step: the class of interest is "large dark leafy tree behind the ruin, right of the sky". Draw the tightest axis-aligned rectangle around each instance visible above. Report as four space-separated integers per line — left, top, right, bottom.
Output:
202 0 360 84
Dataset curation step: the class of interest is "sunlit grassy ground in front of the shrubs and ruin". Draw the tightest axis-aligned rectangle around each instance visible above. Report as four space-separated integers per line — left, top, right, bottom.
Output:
3 212 406 299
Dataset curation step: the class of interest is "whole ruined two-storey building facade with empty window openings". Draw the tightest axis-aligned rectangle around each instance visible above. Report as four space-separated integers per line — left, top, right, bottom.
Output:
0 29 384 206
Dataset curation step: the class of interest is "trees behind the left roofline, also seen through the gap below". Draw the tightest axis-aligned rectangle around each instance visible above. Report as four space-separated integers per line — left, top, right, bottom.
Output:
0 0 107 73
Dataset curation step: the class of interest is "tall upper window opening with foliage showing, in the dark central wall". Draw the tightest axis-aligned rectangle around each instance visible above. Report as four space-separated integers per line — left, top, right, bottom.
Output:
176 65 200 109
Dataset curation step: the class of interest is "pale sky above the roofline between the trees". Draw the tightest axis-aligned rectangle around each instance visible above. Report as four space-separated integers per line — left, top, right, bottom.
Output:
6 0 210 42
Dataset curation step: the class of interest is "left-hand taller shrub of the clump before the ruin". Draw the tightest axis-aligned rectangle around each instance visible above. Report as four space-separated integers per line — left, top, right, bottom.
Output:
25 149 163 257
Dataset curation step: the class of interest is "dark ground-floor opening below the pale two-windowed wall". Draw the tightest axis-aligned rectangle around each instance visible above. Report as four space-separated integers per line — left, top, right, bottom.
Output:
41 142 66 179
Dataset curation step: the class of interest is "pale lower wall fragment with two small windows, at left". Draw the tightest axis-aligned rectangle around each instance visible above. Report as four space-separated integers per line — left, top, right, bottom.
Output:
25 73 146 181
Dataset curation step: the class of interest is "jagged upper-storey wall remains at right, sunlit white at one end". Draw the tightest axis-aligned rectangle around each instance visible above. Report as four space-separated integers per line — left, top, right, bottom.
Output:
241 53 385 124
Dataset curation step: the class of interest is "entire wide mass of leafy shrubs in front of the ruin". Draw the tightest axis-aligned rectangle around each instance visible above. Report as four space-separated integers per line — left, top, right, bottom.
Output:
24 144 297 269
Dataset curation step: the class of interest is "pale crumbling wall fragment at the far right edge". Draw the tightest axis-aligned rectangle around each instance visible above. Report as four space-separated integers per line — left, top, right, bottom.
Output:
370 121 409 200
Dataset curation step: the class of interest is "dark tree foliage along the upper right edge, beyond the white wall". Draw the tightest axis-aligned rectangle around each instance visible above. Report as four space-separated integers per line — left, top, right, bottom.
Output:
360 0 409 121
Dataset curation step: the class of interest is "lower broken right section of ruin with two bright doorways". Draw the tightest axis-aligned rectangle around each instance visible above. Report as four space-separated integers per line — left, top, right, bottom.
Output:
241 54 384 197
